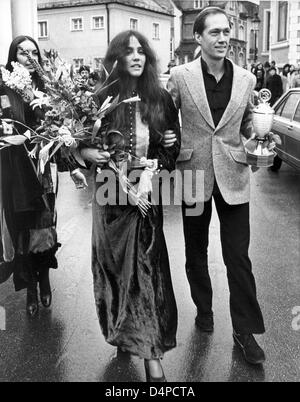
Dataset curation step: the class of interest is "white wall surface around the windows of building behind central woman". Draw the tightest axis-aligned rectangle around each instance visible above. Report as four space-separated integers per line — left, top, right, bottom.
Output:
38 0 172 71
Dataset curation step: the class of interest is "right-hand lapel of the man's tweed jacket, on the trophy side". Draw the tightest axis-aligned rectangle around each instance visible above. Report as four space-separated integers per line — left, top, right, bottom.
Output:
216 60 248 131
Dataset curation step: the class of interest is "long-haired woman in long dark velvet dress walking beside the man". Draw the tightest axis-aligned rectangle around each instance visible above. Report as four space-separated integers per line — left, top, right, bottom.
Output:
81 31 179 381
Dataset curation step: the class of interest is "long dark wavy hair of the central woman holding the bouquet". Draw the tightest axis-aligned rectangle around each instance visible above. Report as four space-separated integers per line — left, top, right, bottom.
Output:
100 30 164 131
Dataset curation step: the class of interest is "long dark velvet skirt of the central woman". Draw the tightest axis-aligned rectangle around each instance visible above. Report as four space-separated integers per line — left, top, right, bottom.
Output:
92 187 177 359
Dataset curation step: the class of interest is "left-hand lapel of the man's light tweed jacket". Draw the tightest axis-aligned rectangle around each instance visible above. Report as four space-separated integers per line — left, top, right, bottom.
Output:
184 58 215 130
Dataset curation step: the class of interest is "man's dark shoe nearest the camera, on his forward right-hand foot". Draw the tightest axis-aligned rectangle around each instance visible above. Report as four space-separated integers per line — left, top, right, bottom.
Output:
233 332 266 364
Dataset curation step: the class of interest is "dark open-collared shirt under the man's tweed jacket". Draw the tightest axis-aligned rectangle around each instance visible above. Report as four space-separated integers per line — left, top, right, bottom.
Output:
201 58 233 127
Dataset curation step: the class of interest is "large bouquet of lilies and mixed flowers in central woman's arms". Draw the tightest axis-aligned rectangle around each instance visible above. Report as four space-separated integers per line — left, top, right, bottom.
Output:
0 50 155 216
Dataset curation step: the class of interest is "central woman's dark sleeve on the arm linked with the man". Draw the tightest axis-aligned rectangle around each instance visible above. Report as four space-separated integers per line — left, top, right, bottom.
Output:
148 91 181 172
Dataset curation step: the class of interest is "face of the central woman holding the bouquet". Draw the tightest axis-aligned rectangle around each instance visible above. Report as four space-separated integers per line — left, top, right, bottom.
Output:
125 36 146 78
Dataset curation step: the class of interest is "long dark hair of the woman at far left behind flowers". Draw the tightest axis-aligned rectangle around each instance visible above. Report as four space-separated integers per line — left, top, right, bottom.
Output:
6 35 44 123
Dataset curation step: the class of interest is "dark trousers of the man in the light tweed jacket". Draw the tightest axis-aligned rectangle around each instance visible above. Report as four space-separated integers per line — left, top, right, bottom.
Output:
182 185 265 334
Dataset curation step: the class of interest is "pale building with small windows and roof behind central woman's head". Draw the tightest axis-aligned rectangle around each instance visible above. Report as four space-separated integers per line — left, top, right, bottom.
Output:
38 0 173 70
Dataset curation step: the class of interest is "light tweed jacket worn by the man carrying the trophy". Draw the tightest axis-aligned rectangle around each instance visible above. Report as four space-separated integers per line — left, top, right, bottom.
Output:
168 59 256 205
